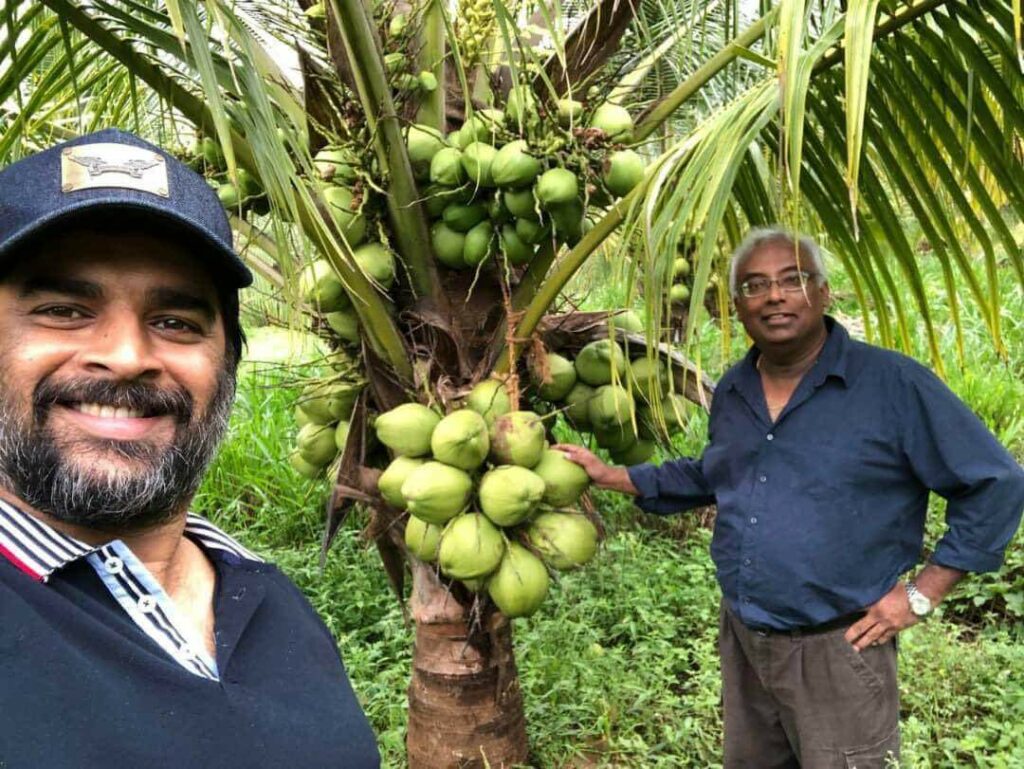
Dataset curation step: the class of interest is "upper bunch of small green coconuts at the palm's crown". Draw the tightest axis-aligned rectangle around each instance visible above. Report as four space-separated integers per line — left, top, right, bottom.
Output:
407 96 644 270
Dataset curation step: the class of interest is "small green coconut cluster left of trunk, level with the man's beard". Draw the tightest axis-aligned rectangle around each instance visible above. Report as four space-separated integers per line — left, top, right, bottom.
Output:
289 370 364 478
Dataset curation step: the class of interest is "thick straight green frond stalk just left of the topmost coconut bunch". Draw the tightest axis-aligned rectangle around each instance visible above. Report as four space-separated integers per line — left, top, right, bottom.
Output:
331 0 447 309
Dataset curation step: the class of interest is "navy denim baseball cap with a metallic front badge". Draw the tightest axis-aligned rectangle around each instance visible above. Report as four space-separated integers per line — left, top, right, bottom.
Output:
0 128 253 289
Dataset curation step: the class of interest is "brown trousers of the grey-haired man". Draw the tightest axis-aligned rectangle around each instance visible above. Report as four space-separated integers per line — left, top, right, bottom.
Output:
719 601 899 769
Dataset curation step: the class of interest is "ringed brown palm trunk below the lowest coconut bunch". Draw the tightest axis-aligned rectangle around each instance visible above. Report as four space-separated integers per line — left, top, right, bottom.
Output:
407 559 528 769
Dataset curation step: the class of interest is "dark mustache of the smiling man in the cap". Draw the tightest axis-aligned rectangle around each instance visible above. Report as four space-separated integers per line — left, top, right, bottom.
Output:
33 378 194 424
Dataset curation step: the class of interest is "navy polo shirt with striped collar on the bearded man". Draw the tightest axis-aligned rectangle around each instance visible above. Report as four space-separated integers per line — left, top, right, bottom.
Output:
0 501 380 769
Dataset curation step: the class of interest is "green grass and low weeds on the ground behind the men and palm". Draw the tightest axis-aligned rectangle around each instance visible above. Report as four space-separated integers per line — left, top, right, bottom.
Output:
195 236 1024 769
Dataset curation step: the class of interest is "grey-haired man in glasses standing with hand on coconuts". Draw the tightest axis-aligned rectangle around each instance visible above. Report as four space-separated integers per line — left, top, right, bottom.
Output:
561 229 1024 769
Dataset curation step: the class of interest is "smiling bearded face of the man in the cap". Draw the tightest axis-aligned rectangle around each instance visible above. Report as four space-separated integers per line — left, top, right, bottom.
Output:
0 229 234 529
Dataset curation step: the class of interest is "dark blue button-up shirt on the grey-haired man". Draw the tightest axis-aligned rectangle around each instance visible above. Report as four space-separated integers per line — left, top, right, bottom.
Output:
629 317 1024 630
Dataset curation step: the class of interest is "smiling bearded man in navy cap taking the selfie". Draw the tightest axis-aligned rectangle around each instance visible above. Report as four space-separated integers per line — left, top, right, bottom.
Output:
0 130 379 769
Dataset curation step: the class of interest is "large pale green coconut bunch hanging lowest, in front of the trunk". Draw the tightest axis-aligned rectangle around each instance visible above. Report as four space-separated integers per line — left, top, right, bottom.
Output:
375 393 598 617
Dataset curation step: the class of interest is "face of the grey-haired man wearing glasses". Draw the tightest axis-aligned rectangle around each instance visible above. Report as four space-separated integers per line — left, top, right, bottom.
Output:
735 242 829 349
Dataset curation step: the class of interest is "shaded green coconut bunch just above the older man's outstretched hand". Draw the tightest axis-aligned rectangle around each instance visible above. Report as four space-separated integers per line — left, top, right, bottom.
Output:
529 331 687 465
